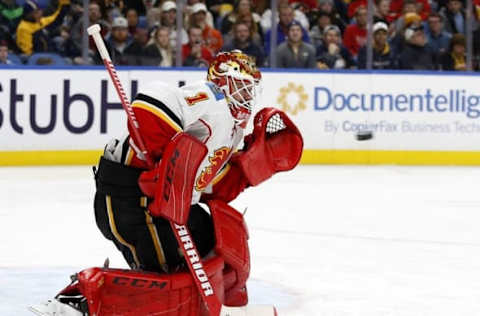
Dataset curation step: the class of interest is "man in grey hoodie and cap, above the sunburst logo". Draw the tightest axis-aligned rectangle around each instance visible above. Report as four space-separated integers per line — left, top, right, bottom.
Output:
276 21 316 68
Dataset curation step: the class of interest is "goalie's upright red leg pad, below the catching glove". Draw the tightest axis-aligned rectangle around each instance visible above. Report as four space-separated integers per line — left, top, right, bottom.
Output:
207 200 250 306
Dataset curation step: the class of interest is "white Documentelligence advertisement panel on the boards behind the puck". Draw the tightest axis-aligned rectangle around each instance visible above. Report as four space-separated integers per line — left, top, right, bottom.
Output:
260 73 480 151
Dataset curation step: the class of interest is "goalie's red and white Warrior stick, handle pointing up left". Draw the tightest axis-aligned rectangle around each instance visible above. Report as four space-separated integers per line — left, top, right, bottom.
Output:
87 24 225 316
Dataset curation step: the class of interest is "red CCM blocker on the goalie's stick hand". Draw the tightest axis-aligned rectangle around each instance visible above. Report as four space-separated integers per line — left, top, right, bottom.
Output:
138 133 208 225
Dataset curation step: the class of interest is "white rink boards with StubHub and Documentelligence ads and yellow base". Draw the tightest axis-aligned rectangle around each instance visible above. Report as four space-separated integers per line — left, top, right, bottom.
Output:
0 67 480 165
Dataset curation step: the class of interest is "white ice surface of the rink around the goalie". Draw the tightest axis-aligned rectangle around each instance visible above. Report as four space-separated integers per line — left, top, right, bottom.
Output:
0 166 480 316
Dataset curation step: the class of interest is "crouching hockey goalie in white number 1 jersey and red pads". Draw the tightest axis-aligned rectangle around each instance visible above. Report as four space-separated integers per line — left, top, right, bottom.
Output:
31 51 303 316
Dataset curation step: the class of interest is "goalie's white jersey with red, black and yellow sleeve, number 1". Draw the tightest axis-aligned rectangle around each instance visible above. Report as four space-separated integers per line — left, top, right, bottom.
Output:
105 81 244 204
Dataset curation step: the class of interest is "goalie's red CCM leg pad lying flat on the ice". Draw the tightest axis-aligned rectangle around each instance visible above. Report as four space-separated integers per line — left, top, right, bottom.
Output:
57 257 224 316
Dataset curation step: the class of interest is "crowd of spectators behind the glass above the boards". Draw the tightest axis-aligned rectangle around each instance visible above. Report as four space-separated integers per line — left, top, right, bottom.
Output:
0 0 480 71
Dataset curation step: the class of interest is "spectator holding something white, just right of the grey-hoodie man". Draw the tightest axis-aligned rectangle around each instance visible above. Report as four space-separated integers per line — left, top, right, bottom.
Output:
317 25 355 69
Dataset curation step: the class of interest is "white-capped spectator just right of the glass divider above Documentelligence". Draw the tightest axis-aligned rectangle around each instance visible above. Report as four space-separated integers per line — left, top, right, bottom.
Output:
357 22 395 69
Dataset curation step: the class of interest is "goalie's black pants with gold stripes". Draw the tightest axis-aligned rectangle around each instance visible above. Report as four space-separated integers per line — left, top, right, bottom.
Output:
94 157 215 272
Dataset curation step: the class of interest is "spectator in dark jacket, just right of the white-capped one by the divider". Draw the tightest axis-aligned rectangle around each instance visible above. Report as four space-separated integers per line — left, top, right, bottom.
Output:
398 26 435 70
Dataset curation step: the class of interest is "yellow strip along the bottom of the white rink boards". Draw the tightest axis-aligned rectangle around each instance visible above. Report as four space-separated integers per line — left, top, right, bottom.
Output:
4 149 480 167
